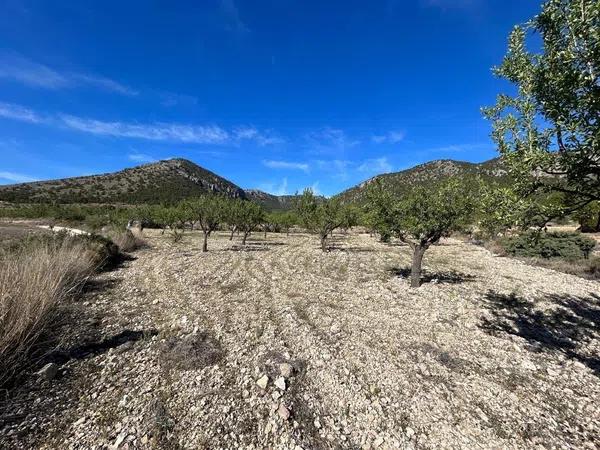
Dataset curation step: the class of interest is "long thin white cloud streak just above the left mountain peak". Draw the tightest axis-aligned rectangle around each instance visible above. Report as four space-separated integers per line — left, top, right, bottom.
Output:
60 115 230 144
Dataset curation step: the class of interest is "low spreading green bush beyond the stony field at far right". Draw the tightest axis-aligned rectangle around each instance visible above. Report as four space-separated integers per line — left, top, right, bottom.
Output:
501 231 596 259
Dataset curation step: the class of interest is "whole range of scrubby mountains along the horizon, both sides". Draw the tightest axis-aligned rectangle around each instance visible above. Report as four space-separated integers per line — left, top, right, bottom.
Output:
0 158 507 210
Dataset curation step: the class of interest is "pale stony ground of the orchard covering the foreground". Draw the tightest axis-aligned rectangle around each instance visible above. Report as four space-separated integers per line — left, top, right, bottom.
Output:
0 231 600 449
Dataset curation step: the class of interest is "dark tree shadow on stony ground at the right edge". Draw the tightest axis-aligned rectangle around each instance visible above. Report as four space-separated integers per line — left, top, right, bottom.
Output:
479 291 600 377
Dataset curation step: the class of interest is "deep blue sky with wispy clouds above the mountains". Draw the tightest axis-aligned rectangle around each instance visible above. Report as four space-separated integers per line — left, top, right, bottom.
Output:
0 0 540 195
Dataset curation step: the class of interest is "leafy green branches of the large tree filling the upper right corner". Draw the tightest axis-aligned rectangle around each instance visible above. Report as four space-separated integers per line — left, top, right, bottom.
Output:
483 0 600 220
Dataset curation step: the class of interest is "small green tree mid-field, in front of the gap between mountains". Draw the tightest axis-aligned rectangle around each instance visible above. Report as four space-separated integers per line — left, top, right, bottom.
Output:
296 189 352 252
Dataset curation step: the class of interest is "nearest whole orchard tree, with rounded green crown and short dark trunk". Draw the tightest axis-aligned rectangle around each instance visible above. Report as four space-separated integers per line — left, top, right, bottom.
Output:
369 179 475 287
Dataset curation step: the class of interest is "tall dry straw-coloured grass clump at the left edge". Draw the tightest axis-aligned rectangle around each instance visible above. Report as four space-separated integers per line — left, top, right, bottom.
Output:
0 238 98 385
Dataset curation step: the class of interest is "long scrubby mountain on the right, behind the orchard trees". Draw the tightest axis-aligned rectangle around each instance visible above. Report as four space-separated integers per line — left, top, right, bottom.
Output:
337 158 508 203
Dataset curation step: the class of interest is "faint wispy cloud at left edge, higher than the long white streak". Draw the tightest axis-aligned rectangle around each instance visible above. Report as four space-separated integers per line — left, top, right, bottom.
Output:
0 52 138 96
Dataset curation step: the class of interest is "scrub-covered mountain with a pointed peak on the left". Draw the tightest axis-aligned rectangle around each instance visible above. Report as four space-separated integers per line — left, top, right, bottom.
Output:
0 159 245 203
